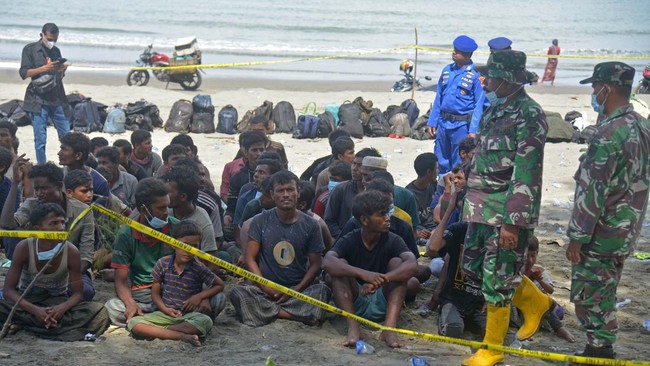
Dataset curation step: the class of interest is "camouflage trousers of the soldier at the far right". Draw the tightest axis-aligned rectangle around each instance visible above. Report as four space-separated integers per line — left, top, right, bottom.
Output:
571 252 626 347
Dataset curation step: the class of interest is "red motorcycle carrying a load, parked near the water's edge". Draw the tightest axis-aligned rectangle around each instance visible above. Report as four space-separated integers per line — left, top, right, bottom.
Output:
126 44 201 90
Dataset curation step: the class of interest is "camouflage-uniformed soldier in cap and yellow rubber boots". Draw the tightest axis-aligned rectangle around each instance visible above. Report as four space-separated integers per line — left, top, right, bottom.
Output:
462 50 551 365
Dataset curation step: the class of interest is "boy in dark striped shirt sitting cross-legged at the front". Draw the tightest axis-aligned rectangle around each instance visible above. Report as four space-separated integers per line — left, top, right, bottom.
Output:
127 220 224 346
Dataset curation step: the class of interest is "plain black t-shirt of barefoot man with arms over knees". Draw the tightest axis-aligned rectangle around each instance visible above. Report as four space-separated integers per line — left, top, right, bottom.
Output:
332 229 410 283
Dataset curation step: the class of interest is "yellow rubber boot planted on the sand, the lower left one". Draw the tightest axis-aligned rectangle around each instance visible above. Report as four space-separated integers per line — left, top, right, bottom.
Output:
462 304 510 366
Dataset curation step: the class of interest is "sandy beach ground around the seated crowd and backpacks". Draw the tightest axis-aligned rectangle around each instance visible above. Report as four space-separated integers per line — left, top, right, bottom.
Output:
0 69 650 366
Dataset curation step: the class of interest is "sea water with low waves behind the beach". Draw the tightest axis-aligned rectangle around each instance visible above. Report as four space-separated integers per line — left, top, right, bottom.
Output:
0 0 650 85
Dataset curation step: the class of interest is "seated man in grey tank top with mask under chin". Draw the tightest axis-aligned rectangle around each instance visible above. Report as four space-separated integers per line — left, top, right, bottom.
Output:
0 203 109 342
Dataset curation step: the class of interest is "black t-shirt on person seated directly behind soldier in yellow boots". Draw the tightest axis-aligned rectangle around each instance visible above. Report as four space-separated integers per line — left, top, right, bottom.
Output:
440 222 485 311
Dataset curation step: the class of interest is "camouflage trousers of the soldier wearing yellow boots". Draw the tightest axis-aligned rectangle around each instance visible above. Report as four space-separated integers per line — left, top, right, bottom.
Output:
463 222 533 307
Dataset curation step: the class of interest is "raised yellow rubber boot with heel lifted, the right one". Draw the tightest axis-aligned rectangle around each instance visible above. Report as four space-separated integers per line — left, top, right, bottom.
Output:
512 276 553 341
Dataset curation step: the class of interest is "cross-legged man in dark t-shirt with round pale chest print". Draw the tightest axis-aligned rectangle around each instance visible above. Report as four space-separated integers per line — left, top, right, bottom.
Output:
230 171 331 326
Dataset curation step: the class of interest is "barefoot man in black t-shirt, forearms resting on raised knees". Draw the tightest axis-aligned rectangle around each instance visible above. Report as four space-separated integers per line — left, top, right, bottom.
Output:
323 190 418 348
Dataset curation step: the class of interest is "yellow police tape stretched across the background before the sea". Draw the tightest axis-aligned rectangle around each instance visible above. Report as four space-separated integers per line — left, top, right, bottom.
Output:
130 45 650 71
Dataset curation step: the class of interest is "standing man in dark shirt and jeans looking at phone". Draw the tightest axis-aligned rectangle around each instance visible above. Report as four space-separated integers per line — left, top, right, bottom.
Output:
18 23 70 164
